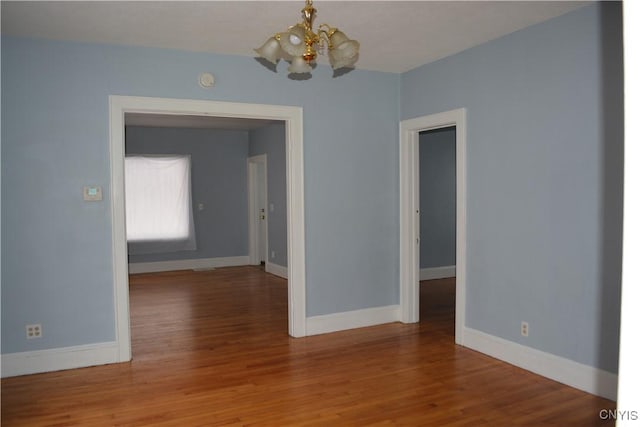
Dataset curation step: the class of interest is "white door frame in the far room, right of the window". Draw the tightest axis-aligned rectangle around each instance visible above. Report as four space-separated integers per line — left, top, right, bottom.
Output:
247 154 269 271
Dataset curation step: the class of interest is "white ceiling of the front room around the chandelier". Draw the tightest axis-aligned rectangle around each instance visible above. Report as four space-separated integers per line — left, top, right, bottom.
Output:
1 0 588 73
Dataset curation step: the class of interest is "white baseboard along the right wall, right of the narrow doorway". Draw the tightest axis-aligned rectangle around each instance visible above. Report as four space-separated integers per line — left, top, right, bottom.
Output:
463 328 618 401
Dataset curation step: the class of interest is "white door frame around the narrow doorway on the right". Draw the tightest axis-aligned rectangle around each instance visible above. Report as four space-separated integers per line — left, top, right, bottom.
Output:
400 108 467 345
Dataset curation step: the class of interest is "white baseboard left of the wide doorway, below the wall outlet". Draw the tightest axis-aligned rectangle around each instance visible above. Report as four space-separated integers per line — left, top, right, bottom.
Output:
2 342 121 378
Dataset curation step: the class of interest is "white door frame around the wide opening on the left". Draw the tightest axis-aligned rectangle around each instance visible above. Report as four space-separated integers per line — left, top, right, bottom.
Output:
109 96 306 362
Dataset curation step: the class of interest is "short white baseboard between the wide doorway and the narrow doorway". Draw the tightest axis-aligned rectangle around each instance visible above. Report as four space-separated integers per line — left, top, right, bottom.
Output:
307 305 400 335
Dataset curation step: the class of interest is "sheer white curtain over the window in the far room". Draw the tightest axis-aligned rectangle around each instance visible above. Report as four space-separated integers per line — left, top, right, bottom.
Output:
125 155 196 254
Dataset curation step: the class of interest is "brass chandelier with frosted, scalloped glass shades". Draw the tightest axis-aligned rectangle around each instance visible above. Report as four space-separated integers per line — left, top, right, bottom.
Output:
255 0 360 74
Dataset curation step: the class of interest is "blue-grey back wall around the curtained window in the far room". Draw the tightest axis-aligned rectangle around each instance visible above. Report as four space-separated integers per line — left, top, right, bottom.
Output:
125 126 249 262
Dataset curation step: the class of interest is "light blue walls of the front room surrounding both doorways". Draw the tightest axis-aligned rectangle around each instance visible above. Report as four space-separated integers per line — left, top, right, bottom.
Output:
1 2 623 378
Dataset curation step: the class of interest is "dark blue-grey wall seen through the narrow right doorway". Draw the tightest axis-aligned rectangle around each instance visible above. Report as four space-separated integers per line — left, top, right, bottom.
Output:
419 127 456 268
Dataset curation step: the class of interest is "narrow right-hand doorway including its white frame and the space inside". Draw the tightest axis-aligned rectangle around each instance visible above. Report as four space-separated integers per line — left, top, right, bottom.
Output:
400 109 467 344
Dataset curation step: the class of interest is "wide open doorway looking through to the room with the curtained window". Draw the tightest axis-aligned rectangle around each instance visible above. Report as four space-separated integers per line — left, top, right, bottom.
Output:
119 113 287 359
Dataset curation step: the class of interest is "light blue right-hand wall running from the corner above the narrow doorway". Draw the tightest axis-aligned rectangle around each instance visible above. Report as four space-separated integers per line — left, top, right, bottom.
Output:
400 2 623 372
